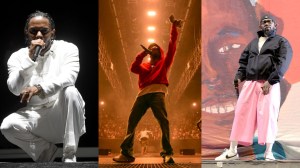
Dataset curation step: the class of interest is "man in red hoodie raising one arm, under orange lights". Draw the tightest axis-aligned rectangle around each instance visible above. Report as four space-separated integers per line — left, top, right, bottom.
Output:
113 15 182 163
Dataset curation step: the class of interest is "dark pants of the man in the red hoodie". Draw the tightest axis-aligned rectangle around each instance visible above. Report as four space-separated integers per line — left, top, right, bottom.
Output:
121 93 173 156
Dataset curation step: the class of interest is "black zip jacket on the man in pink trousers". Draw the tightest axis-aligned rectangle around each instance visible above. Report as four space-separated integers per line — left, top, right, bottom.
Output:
235 31 293 85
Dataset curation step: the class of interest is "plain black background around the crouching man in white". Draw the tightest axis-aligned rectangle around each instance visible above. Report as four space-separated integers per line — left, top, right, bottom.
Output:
0 0 98 149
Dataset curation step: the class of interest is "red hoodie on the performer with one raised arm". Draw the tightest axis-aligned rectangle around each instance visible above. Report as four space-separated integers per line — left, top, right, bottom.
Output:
130 24 178 89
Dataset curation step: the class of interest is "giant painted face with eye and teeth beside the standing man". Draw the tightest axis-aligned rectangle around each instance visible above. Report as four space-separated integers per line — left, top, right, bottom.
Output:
202 0 258 113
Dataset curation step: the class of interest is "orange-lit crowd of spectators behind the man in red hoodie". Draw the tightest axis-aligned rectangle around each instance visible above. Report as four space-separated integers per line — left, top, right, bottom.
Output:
99 111 200 141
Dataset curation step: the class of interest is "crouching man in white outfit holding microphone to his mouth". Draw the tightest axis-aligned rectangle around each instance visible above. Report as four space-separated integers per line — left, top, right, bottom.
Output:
1 11 86 162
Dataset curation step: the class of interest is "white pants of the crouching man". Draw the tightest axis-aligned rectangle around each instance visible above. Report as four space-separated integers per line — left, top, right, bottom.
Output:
1 86 86 161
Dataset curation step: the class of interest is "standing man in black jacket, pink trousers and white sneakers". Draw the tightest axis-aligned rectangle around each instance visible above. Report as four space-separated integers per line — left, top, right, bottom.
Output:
215 15 293 161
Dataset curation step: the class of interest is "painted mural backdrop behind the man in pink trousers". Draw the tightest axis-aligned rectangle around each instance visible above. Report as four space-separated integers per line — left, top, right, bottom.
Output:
201 0 300 158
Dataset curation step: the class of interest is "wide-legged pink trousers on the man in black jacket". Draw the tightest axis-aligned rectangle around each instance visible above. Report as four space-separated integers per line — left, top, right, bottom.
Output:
230 81 280 146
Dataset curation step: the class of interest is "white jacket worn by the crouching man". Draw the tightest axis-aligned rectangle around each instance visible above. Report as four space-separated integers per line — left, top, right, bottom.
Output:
7 40 80 106
